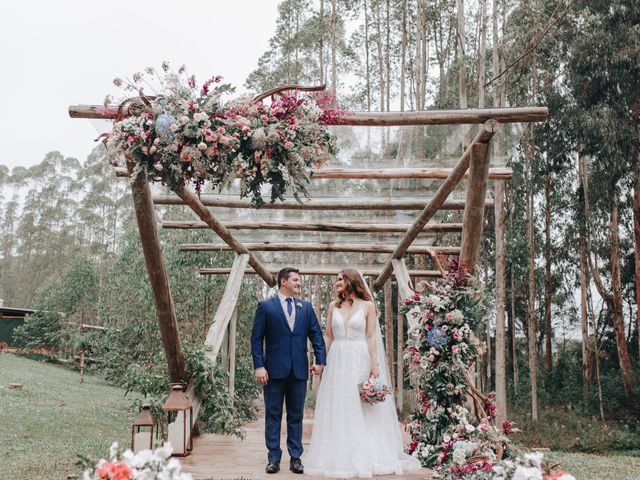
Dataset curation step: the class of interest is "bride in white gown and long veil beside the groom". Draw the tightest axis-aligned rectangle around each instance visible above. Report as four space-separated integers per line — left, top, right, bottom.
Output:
304 268 420 478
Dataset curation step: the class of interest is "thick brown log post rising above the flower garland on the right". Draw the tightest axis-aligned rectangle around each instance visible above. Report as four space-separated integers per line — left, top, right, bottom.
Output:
460 143 489 272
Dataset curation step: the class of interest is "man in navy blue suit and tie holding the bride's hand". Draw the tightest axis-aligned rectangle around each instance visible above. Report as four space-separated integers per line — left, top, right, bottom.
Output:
251 267 326 473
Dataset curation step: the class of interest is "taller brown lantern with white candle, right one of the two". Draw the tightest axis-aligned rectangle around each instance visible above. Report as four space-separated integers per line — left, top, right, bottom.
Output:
162 383 193 457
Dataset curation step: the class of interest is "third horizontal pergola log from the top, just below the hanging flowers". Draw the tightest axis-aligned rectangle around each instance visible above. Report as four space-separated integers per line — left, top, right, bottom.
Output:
153 195 493 210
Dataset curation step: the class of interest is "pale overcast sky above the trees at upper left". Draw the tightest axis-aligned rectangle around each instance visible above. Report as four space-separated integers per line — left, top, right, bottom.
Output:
0 0 278 168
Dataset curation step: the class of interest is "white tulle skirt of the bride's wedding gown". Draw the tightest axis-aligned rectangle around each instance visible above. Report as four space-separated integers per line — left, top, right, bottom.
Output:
304 340 420 478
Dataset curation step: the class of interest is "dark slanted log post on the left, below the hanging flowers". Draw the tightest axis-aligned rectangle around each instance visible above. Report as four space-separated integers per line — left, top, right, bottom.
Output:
129 162 187 383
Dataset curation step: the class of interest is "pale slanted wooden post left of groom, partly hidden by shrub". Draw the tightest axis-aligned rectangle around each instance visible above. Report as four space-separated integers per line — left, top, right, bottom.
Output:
187 254 249 422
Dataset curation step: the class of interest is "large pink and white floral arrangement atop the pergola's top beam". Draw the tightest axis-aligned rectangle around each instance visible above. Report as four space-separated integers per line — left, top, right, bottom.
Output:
105 62 341 207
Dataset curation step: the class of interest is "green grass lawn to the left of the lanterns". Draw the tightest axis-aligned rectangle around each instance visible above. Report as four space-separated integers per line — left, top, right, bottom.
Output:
0 353 139 480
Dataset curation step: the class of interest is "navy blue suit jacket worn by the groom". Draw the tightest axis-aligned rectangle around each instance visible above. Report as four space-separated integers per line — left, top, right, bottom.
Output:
251 295 326 380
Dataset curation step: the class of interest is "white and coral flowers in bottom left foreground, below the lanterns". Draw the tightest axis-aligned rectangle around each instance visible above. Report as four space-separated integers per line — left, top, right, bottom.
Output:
82 442 191 480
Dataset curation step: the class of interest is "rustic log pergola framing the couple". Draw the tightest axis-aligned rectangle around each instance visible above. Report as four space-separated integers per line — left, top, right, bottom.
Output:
69 105 548 464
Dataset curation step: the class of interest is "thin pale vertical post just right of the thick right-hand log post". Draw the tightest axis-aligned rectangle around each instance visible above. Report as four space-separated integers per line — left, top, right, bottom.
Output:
489 181 507 425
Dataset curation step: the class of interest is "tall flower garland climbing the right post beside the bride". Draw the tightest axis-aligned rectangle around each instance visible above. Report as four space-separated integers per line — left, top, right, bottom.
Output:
402 259 575 480
